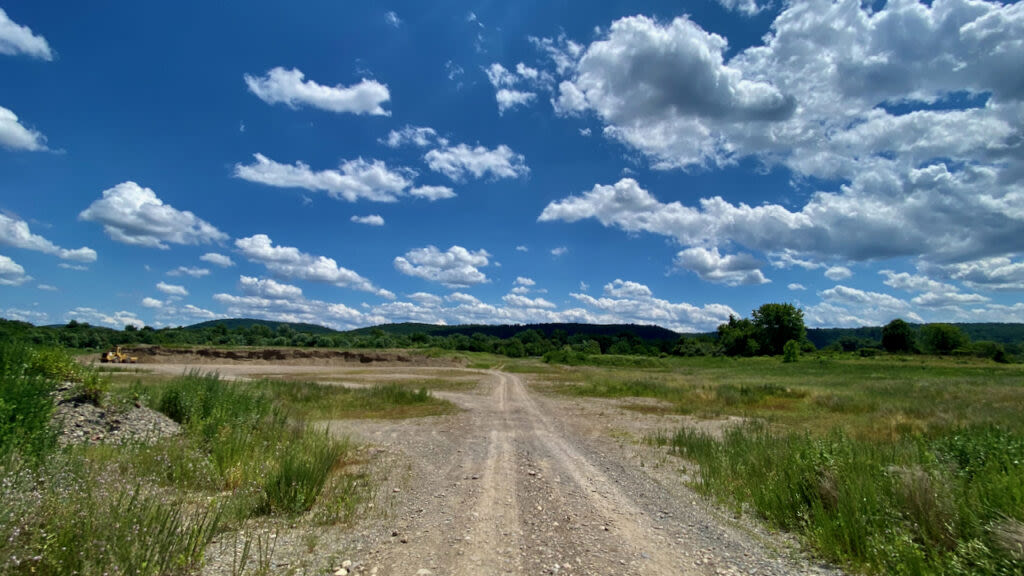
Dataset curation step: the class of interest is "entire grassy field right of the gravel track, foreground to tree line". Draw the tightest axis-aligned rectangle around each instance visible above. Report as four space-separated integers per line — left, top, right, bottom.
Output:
536 356 1024 575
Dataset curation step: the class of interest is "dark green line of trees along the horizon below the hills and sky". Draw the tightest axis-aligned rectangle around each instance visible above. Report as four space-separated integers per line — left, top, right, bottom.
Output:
0 303 1024 362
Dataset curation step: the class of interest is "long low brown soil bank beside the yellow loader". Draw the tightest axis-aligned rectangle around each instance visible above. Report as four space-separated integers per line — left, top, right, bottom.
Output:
115 346 460 366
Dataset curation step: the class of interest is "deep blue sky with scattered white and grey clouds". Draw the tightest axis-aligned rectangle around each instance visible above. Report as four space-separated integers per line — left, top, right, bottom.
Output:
0 0 1024 331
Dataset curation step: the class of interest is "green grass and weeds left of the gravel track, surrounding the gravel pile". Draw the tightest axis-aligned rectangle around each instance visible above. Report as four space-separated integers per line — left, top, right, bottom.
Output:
0 341 450 575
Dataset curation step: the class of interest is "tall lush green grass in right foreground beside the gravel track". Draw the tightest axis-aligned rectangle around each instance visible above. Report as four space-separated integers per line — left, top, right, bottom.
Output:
655 424 1024 574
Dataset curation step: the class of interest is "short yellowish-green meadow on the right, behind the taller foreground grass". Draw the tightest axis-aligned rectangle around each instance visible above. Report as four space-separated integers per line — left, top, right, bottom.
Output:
537 356 1024 441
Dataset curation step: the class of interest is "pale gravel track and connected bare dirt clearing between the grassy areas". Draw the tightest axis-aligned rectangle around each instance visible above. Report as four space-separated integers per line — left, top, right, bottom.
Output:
145 363 839 576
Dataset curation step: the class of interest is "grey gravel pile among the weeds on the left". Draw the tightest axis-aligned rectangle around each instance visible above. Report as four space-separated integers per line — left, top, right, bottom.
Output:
53 382 181 446
